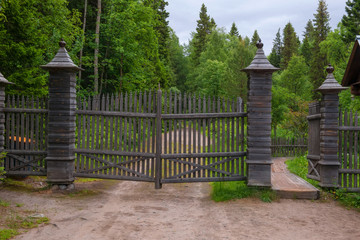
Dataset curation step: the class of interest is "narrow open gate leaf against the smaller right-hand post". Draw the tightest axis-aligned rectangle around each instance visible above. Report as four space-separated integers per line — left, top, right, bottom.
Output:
307 102 321 181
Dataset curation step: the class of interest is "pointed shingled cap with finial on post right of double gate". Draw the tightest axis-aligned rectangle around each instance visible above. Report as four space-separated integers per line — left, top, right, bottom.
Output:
241 39 280 72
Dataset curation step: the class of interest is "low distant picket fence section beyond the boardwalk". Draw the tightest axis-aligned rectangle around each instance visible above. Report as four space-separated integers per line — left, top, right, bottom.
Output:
271 137 308 157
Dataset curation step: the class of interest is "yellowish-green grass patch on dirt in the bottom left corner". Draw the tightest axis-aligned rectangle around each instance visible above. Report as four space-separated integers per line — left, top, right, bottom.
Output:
0 199 49 240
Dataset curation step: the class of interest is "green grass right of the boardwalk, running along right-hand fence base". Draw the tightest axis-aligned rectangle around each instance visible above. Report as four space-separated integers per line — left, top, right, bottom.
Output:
286 156 360 211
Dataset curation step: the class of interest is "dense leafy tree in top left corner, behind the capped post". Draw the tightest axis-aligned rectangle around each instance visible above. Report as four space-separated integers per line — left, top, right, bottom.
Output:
0 0 82 96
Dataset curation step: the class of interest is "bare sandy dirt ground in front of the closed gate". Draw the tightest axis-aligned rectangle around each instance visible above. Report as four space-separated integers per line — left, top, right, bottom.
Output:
0 181 360 240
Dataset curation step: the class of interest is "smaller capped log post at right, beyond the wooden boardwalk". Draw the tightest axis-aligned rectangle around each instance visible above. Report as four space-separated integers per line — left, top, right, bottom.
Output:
317 64 347 187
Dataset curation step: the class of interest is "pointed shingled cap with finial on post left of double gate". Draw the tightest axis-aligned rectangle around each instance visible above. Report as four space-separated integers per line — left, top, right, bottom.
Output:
40 39 84 72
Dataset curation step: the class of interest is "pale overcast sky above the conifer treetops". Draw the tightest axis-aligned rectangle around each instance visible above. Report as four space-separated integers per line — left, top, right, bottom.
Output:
167 0 346 55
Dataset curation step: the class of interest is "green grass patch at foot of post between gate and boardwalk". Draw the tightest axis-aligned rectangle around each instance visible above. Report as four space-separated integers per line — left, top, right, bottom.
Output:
211 182 277 202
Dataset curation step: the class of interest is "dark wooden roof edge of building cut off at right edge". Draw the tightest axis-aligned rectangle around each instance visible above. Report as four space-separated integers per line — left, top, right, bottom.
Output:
341 36 360 96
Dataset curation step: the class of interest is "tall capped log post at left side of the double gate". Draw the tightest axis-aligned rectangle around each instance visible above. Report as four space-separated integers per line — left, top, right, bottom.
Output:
41 40 81 189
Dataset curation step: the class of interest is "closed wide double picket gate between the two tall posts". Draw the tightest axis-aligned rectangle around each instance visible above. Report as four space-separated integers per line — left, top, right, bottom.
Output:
75 90 246 187
